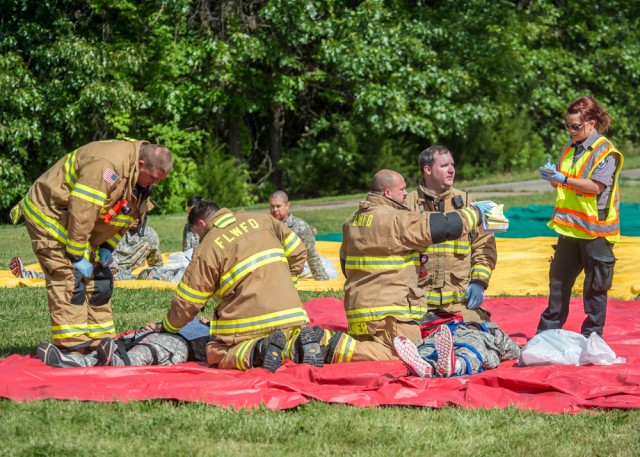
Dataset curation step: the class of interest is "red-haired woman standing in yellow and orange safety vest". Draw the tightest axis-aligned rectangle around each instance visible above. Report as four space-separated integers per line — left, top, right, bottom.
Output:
537 96 624 338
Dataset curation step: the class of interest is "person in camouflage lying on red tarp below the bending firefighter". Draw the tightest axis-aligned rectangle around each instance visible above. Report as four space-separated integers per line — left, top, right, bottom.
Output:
37 318 209 368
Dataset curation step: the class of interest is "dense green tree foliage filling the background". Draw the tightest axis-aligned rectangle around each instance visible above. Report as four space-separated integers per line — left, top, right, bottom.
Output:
0 0 640 212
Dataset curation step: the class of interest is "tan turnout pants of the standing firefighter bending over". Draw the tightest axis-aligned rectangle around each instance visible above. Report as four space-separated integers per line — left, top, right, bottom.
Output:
26 219 115 351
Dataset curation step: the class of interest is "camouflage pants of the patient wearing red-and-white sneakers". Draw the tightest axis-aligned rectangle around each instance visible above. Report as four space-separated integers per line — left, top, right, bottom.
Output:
416 322 520 374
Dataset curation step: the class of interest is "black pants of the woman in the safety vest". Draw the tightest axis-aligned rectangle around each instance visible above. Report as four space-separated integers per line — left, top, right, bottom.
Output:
537 236 615 338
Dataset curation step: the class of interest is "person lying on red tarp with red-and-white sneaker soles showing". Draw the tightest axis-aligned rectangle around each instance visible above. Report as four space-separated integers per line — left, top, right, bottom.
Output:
393 312 521 378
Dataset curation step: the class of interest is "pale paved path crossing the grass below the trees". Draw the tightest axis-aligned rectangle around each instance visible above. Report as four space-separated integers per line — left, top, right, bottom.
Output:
291 168 640 212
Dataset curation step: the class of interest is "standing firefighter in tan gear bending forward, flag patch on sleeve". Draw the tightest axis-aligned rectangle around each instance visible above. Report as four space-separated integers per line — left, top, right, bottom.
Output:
20 140 173 352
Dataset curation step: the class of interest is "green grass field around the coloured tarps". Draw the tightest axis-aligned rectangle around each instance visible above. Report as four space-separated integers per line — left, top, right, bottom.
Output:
0 180 640 457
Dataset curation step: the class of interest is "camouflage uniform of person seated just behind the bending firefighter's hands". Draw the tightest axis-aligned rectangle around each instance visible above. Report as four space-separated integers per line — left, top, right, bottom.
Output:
110 227 164 280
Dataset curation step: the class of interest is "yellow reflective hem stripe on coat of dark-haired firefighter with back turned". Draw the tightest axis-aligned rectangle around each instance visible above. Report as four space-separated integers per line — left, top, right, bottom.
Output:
210 308 309 336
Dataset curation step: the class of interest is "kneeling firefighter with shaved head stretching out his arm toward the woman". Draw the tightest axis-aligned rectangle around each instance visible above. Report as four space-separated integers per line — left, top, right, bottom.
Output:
340 170 491 362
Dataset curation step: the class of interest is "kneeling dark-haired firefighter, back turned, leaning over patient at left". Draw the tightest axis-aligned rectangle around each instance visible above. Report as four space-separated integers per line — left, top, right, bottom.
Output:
158 199 350 372
